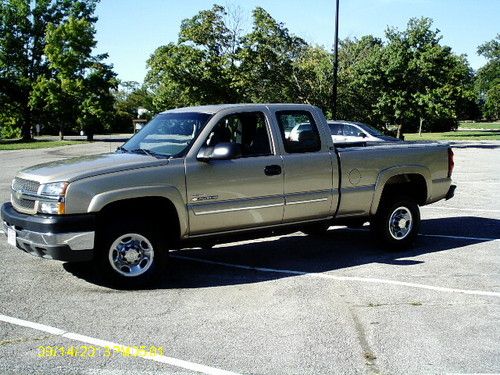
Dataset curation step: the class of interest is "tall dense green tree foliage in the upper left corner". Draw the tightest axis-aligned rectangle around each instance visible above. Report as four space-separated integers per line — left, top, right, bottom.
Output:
0 0 115 139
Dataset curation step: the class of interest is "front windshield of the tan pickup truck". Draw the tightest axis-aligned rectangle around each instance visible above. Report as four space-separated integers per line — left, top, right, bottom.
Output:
123 112 211 157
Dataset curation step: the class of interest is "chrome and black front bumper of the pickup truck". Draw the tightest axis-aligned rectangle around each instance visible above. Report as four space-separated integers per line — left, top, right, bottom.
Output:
0 203 95 262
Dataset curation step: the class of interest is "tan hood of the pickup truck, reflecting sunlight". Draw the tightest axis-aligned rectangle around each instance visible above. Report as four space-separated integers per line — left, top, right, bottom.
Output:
17 153 168 184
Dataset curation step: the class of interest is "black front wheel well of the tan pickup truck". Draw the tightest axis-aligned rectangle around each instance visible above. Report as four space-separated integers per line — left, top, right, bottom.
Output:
97 197 180 240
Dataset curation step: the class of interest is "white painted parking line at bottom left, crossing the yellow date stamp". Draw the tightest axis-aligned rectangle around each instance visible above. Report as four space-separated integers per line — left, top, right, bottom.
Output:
0 314 238 375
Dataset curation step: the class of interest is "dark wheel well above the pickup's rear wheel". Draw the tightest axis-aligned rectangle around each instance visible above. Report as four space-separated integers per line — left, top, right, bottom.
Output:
380 174 427 205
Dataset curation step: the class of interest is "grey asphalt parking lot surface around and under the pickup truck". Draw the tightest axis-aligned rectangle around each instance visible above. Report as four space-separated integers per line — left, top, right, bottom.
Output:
0 142 500 374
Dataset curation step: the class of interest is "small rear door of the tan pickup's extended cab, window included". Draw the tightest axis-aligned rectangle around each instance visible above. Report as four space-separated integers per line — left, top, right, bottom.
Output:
275 110 338 222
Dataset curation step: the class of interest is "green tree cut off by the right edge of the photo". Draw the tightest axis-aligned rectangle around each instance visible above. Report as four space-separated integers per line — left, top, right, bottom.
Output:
476 34 500 119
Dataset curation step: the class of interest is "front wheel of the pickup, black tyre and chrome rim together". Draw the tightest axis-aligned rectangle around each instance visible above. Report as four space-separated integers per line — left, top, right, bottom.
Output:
99 222 168 288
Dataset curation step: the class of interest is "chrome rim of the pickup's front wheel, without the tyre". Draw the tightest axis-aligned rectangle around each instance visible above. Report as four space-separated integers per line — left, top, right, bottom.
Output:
108 233 154 277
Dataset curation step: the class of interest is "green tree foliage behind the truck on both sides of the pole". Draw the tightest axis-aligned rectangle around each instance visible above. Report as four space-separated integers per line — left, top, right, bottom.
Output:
146 5 472 135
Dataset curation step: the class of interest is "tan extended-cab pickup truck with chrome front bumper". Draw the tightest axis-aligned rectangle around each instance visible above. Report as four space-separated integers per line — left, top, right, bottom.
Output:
1 104 456 285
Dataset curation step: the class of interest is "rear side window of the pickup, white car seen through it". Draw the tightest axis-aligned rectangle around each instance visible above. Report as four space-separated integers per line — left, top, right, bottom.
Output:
276 111 321 154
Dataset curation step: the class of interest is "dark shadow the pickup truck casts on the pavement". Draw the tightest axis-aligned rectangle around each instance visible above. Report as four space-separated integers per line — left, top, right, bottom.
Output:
63 217 500 289
